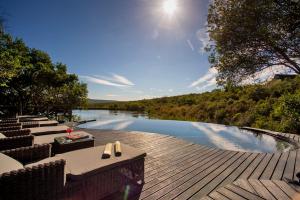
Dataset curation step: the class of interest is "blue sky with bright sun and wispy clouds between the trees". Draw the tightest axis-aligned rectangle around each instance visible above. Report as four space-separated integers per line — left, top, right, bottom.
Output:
0 0 216 100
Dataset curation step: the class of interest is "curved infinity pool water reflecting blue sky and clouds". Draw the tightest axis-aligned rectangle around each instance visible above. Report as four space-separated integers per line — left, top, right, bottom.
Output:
73 110 293 152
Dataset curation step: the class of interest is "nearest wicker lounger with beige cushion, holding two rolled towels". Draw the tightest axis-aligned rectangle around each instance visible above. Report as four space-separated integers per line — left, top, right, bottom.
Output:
0 145 146 200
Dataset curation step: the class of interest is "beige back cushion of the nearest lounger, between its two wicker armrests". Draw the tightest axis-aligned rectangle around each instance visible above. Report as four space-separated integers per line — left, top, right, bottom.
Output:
0 153 24 174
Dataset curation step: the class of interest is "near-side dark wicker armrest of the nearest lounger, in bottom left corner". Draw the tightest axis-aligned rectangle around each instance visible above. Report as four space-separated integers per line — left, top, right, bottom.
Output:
0 160 65 199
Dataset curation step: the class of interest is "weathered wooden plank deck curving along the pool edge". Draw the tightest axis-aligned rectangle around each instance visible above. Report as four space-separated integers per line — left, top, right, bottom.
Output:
84 129 300 200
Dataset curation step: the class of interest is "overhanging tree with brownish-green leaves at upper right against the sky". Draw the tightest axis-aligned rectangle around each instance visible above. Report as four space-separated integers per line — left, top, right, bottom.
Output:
207 0 300 84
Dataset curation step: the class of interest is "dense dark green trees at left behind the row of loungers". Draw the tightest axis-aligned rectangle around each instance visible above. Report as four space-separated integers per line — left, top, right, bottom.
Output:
0 32 87 113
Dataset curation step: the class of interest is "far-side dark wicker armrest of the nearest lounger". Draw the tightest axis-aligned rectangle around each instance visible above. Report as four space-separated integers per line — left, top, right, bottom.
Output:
1 144 51 165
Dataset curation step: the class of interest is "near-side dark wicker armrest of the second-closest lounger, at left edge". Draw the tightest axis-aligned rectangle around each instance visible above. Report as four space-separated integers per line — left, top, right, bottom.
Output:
0 135 33 151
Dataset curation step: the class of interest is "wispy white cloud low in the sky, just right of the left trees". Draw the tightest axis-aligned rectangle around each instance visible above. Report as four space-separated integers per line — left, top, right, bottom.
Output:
79 74 135 87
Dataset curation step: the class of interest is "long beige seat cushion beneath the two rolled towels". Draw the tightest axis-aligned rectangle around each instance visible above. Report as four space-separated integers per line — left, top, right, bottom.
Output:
55 144 146 180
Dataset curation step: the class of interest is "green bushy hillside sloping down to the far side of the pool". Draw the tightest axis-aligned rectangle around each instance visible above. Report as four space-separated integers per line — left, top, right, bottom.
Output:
88 76 300 133
